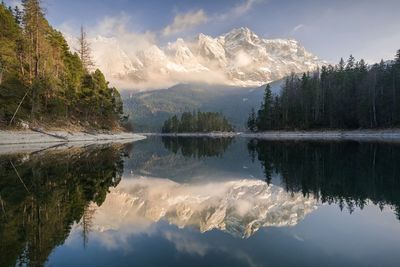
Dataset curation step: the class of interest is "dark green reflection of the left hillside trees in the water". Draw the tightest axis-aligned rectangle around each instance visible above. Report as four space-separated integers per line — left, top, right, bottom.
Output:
0 146 123 266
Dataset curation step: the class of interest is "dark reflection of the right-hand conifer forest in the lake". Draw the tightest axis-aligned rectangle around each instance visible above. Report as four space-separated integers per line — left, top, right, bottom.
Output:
248 140 400 219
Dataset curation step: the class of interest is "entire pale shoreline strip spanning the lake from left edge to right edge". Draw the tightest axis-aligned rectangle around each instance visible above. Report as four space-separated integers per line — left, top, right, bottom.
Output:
0 129 400 148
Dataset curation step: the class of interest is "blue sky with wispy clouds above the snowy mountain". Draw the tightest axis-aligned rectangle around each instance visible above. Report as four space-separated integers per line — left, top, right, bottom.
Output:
6 0 400 63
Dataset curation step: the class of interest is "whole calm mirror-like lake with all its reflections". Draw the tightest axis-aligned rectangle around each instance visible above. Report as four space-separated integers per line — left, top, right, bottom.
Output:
0 137 400 266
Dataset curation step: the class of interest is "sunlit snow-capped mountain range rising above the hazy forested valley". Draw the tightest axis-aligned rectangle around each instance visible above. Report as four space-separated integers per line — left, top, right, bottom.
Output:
90 28 324 89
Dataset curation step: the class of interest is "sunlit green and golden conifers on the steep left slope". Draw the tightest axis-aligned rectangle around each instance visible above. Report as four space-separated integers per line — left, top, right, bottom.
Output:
0 0 122 128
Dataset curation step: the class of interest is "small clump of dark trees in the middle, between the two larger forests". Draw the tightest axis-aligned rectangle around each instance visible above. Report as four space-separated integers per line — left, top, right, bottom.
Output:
162 111 233 133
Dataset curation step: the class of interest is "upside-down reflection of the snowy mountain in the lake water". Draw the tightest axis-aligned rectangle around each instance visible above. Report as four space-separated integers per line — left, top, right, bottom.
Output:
92 177 317 238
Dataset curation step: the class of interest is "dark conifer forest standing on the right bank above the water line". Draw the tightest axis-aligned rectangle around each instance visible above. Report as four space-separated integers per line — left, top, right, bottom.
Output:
247 50 400 131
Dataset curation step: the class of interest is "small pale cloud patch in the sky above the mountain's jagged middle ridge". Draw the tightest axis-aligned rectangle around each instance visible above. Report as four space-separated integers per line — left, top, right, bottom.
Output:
162 9 208 36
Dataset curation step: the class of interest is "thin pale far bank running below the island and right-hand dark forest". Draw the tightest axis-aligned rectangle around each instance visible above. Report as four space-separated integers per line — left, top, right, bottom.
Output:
141 129 400 142
